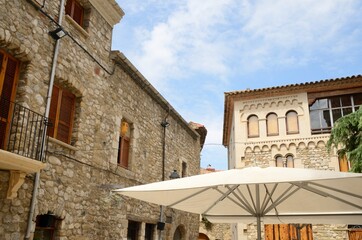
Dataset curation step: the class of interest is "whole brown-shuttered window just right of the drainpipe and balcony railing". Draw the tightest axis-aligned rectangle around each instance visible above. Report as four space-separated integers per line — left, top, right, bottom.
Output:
48 85 75 144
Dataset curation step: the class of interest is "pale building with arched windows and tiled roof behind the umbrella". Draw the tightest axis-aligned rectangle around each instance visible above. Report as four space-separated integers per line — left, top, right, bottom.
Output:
223 75 362 240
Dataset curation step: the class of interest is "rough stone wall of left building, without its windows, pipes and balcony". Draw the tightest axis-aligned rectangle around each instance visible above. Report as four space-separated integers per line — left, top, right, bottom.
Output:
0 0 201 240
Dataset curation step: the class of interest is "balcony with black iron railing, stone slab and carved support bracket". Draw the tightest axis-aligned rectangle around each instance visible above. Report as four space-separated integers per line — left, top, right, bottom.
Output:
0 97 47 199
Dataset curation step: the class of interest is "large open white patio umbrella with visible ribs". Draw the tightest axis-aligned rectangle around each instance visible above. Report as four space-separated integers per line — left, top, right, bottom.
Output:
115 167 362 239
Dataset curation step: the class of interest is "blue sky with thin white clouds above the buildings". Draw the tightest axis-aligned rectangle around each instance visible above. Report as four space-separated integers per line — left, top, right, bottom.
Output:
112 0 362 170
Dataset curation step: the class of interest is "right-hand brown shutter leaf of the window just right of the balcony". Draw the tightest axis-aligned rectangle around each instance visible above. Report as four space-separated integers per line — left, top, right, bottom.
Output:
57 90 75 143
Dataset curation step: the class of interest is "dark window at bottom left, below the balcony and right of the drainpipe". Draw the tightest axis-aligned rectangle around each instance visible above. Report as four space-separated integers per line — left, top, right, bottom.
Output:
34 213 59 240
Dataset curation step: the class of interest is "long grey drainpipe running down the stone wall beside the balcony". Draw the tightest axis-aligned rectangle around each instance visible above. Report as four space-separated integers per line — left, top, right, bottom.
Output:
25 0 65 237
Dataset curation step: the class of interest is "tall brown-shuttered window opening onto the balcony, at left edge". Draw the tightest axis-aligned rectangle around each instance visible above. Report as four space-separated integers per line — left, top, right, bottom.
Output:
0 50 20 149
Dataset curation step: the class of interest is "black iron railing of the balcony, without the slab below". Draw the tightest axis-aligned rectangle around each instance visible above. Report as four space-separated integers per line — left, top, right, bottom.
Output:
0 96 48 161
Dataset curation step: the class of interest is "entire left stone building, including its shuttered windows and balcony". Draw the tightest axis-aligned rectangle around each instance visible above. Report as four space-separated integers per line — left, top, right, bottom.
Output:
0 0 203 240
